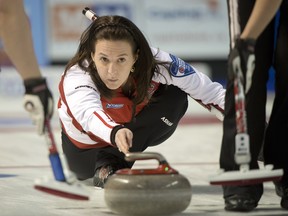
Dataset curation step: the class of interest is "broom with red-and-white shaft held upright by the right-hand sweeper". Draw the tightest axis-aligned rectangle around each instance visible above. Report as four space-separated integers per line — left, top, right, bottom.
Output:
210 0 283 185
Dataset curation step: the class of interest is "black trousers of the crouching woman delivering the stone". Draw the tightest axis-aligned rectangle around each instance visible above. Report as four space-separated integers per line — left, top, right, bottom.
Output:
62 85 188 180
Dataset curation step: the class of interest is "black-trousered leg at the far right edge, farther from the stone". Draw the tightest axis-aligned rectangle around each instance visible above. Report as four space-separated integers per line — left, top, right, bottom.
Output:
264 0 288 209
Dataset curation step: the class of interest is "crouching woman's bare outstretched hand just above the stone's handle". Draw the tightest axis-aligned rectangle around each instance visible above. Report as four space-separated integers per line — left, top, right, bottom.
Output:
115 128 133 154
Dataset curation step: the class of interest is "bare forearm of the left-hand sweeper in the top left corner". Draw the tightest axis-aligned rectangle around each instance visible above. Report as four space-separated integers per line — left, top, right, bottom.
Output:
0 0 42 80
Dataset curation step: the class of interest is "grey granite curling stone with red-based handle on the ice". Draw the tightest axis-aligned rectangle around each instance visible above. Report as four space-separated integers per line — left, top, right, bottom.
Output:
104 152 192 216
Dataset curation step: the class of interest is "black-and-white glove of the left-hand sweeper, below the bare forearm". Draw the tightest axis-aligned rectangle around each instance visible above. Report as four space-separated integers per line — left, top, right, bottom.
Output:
24 78 54 135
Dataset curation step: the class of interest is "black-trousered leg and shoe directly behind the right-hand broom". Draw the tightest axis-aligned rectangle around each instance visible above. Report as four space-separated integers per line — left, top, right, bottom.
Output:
220 0 274 211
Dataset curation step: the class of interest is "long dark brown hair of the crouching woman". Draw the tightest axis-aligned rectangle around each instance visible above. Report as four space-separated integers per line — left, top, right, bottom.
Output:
65 16 167 104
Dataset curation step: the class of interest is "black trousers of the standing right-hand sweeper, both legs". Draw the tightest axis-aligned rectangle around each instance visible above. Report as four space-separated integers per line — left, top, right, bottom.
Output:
220 0 288 199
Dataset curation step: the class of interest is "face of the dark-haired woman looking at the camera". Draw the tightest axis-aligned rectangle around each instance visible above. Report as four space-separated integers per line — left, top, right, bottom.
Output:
91 40 137 90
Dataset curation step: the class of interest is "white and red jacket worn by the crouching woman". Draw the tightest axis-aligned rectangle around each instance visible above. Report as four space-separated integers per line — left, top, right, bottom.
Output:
58 48 225 149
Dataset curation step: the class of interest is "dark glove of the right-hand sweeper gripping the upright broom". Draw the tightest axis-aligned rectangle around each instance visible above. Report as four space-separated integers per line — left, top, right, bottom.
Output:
228 38 256 93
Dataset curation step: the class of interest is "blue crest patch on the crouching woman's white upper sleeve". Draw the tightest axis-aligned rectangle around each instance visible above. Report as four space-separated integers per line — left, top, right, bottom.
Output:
170 54 195 77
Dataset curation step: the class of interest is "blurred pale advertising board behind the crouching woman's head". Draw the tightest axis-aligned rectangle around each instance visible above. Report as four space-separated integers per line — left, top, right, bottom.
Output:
46 0 229 62
